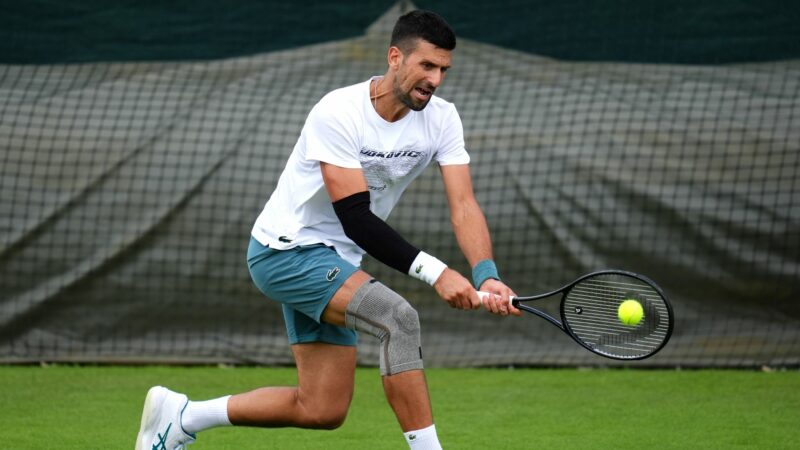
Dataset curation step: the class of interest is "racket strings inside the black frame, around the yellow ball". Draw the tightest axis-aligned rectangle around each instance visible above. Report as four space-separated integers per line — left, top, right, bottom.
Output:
563 274 669 359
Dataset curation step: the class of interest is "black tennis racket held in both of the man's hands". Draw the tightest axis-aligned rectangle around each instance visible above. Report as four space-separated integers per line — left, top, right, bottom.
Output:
478 270 673 360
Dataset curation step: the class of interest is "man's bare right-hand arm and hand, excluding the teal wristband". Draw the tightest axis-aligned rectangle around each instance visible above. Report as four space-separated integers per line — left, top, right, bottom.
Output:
434 164 522 315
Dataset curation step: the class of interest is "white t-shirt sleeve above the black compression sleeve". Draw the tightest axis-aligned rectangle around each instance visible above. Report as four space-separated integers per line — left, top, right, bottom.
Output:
303 98 361 169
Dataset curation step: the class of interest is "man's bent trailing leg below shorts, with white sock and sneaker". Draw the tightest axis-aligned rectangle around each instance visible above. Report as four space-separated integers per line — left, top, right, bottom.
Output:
141 342 356 450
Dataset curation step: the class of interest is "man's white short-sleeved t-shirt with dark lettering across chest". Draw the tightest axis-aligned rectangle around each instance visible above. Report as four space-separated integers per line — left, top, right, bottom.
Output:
252 77 469 266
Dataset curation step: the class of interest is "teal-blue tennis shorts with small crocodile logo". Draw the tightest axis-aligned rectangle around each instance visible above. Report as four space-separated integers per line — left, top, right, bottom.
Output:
247 237 358 346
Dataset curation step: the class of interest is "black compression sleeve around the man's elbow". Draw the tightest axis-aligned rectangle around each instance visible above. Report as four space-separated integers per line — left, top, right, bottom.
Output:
333 191 419 274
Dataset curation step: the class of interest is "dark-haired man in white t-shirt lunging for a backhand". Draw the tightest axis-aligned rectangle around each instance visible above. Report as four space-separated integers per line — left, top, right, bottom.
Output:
136 11 520 450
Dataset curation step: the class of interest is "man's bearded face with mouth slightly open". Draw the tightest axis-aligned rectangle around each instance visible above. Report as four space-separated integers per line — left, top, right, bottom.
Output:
392 39 451 111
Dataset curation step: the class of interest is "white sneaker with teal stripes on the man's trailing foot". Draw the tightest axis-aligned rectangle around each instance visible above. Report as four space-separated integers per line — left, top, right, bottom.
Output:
136 386 195 450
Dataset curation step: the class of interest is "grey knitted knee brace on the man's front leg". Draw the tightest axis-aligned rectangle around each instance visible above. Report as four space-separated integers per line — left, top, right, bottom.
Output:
345 280 422 375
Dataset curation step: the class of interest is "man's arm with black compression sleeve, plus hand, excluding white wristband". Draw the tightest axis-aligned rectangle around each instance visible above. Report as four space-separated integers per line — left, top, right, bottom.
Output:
320 163 480 309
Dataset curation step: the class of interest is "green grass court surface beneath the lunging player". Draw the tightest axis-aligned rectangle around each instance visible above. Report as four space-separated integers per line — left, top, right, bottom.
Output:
0 366 800 450
